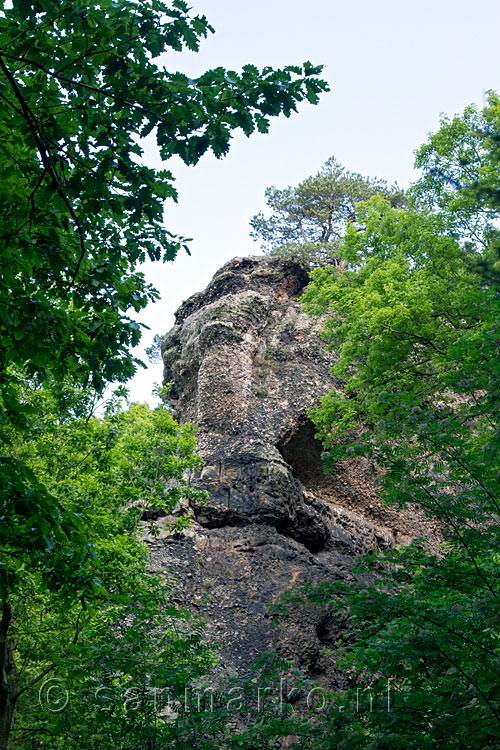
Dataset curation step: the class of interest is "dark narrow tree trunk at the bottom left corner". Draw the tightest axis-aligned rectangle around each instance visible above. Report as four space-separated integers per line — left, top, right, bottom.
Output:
0 601 18 750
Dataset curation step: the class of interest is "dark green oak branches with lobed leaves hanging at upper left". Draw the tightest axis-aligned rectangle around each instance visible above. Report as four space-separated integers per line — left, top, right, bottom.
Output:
0 0 328 400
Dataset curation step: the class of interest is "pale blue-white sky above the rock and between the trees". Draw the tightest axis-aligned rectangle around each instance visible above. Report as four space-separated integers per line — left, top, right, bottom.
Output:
128 0 500 402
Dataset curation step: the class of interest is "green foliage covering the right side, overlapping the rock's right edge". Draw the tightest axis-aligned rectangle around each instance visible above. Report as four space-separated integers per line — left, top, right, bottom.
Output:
296 93 500 750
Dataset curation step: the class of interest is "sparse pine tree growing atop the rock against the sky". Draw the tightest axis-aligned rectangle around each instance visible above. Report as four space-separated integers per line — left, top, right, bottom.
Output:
250 157 404 268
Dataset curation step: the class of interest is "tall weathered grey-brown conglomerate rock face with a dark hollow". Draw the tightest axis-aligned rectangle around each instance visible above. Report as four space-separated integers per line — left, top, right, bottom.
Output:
151 257 433 687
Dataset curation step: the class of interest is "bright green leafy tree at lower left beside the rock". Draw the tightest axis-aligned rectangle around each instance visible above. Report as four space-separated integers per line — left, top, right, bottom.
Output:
0 384 211 750
